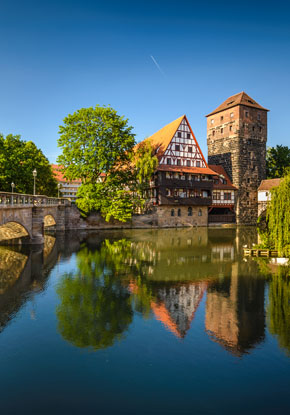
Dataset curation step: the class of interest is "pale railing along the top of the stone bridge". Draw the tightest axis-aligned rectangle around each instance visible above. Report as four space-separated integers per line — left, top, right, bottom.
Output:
0 192 71 209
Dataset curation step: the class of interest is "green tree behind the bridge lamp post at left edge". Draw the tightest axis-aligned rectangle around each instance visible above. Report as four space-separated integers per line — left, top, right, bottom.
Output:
0 134 57 196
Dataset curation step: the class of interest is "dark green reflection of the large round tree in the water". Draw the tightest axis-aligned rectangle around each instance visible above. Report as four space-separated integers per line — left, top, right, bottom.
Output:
56 246 132 350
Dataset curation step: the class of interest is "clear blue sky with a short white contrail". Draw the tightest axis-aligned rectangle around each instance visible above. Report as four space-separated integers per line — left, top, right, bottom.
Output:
0 0 290 162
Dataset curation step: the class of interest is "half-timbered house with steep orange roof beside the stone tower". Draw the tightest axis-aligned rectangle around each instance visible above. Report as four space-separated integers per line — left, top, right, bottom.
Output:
143 115 217 226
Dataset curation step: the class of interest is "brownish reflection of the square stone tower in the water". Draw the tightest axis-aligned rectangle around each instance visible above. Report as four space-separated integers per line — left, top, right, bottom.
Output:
205 263 265 355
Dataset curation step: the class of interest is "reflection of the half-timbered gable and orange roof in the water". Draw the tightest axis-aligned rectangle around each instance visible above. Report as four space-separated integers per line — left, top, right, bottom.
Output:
151 282 206 337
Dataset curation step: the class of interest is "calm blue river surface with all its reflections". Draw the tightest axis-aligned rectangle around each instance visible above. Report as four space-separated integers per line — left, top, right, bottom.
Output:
0 229 290 415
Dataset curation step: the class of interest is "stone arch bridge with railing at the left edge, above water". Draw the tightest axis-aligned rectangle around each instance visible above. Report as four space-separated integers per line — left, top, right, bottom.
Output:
0 192 71 244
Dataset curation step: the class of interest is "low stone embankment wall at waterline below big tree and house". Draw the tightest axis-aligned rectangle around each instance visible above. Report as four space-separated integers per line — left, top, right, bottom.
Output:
65 206 208 230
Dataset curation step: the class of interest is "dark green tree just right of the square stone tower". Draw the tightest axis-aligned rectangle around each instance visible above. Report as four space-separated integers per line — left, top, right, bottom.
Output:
266 145 290 179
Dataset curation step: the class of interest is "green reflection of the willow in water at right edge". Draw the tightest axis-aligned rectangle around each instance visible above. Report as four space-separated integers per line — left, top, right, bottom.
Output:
268 266 290 355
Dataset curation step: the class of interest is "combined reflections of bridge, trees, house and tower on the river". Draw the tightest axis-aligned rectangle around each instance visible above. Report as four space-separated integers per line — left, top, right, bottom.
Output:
0 228 290 356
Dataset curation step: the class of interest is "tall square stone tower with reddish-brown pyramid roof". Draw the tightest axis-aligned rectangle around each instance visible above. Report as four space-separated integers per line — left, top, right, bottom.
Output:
206 92 268 225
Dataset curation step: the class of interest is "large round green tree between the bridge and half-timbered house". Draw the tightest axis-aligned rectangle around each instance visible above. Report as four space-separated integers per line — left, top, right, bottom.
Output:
58 106 157 222
